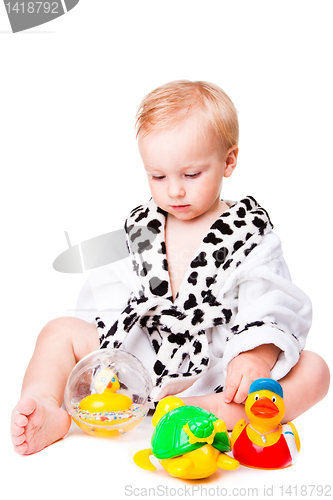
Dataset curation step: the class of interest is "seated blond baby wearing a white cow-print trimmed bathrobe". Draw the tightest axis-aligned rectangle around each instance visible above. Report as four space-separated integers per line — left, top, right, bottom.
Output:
12 81 329 454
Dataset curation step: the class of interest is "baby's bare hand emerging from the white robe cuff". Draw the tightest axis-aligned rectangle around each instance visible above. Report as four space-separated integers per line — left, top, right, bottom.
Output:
224 344 280 403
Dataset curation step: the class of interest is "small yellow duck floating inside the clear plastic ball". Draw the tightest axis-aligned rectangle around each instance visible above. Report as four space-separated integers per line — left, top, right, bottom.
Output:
80 368 132 413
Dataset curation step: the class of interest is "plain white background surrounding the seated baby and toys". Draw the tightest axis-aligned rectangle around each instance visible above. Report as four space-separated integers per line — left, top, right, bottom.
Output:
0 0 333 499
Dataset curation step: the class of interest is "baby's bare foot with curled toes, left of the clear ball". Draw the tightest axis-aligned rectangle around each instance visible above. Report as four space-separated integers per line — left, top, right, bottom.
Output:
11 398 71 455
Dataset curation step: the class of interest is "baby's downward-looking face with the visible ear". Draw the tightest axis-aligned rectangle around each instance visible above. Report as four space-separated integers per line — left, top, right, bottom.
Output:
139 117 238 220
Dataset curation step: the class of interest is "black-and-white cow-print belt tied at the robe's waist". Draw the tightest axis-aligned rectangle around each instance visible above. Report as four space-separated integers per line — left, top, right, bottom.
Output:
109 297 229 390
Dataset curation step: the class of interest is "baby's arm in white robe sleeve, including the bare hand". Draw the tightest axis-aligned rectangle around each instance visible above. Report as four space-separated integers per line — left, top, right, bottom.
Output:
219 233 311 403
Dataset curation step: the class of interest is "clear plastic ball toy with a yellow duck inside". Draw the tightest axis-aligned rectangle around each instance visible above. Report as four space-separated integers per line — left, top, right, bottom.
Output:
65 348 152 437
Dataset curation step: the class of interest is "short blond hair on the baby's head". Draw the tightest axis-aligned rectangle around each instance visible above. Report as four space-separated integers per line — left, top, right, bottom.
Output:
136 80 239 149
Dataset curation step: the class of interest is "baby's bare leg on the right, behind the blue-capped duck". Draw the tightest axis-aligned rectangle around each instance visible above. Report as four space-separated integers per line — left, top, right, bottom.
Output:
183 351 330 430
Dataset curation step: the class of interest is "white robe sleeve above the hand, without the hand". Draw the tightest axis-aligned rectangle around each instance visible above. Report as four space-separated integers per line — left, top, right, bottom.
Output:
223 233 312 380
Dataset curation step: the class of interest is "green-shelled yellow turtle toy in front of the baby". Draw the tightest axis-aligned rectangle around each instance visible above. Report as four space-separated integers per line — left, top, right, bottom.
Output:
133 397 239 479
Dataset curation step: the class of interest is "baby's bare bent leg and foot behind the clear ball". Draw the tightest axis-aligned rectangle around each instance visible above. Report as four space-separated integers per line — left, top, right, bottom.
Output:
12 317 99 455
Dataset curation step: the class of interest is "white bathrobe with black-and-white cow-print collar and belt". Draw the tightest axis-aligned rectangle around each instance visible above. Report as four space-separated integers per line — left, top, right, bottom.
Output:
76 196 311 400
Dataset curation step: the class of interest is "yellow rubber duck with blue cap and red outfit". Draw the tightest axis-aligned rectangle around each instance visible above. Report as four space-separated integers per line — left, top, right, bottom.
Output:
231 378 300 469
